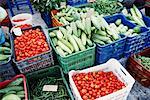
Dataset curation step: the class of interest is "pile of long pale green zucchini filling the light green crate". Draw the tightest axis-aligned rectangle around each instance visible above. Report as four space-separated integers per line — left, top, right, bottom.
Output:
49 18 95 56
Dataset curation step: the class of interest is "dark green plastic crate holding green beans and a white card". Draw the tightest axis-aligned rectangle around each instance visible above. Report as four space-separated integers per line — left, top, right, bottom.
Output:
26 65 74 100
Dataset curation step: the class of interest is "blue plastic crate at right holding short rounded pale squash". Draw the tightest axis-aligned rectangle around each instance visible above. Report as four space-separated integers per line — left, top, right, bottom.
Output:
105 14 149 57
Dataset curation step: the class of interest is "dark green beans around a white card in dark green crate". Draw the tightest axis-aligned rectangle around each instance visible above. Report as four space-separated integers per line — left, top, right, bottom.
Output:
30 77 69 100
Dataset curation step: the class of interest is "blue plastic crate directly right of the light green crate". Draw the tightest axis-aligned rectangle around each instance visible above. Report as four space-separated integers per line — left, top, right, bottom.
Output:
96 35 126 64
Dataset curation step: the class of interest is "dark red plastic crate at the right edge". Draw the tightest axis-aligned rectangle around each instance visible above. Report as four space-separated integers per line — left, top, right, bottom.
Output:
127 48 150 87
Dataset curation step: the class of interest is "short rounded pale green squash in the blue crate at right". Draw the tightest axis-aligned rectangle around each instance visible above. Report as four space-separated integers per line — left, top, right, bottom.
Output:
109 19 141 36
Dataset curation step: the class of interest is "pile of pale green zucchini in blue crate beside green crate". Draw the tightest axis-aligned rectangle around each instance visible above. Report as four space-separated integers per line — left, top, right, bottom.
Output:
91 16 121 45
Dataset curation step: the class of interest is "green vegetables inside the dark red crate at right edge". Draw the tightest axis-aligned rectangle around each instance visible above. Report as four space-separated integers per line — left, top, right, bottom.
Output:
137 56 150 70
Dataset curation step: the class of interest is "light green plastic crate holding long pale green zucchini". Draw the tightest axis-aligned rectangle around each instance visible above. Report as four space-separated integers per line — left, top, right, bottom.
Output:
49 27 96 73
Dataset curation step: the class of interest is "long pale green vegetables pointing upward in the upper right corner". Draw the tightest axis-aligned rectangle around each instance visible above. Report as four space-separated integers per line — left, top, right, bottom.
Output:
122 5 146 27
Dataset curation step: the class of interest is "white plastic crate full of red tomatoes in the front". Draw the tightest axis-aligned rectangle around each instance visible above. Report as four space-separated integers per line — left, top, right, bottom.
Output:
69 59 135 100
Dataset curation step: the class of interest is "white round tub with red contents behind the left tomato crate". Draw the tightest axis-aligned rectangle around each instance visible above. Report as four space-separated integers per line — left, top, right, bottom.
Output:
11 13 32 26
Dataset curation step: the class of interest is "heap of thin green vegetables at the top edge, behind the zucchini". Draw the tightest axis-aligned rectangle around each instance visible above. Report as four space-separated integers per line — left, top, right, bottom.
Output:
91 0 123 15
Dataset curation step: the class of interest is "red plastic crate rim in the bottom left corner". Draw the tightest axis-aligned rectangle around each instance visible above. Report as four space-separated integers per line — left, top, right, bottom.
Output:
0 74 28 100
